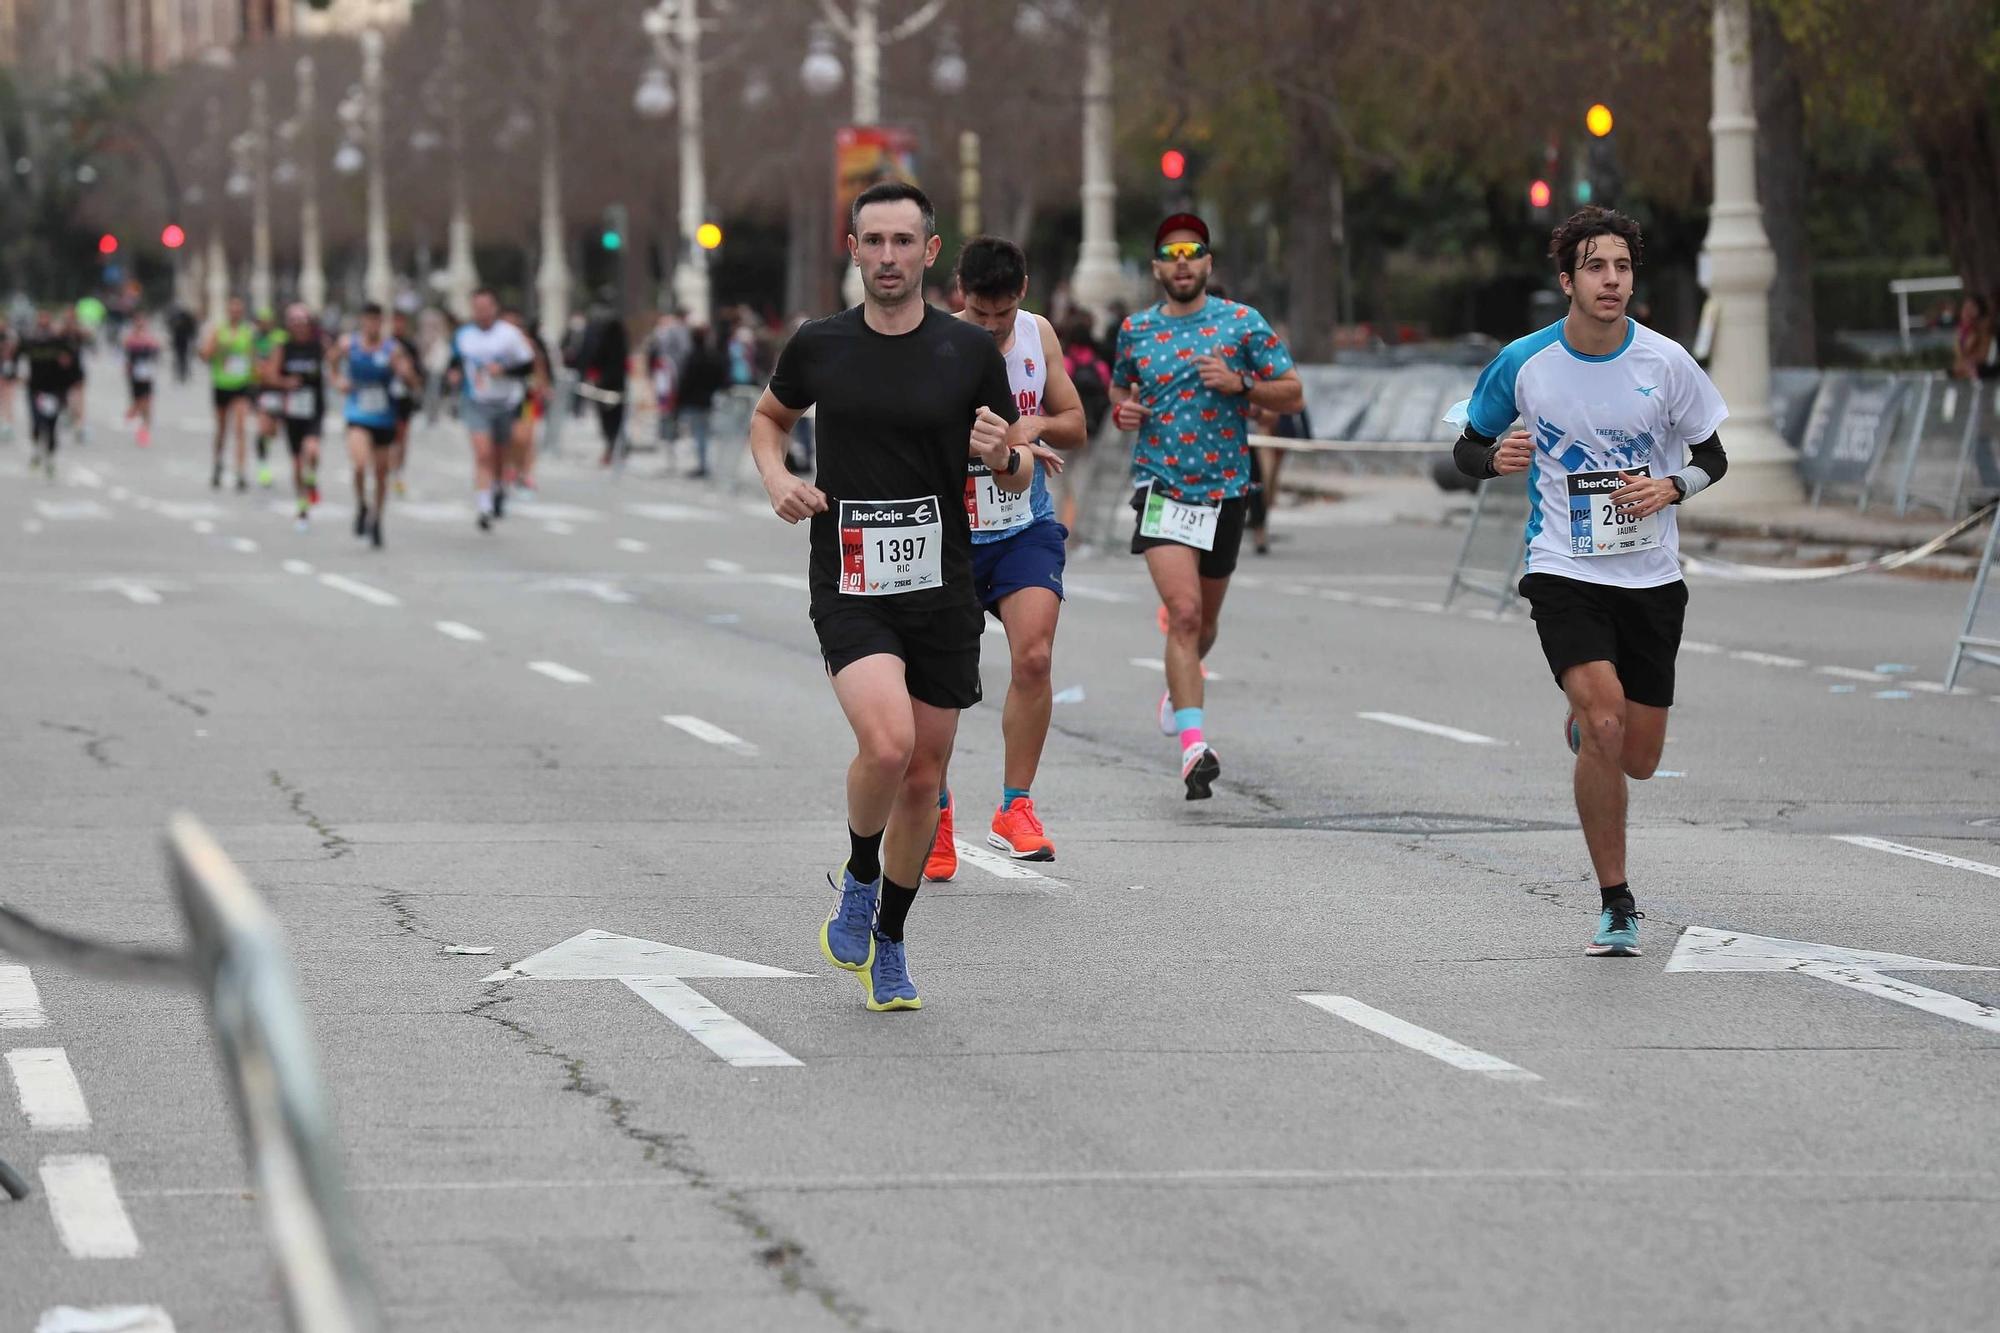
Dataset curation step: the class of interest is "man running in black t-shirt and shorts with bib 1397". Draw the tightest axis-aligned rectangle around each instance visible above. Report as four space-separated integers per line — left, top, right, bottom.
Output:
750 182 1034 1011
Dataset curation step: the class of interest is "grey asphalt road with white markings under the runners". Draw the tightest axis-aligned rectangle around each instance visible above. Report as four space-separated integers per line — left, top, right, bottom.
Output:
0 368 2000 1333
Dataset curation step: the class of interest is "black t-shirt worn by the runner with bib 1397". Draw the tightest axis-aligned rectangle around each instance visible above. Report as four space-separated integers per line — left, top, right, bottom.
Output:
770 306 1018 616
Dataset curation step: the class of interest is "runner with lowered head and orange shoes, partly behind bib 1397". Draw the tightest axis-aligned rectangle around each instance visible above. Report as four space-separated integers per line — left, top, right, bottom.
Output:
924 236 1086 879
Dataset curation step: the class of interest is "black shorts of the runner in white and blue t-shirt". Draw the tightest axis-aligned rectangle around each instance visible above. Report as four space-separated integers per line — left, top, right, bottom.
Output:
1520 574 1688 709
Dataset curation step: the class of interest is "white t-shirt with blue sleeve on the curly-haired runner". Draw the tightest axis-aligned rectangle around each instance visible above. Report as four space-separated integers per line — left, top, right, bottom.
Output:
1466 318 1730 588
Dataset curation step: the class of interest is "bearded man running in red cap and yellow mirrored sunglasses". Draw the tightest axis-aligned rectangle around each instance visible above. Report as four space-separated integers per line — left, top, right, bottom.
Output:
1110 212 1306 801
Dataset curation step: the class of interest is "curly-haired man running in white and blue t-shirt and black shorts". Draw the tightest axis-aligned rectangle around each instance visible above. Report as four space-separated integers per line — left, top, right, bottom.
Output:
1454 208 1728 957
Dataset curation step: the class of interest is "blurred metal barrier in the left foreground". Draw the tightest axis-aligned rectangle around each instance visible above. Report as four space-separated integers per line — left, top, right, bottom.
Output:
0 815 380 1333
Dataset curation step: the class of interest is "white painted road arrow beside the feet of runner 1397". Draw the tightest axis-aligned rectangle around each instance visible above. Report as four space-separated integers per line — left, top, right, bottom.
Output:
486 931 804 1069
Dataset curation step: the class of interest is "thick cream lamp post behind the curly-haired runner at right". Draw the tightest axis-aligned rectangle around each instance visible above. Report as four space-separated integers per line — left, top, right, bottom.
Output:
1702 0 1802 510
